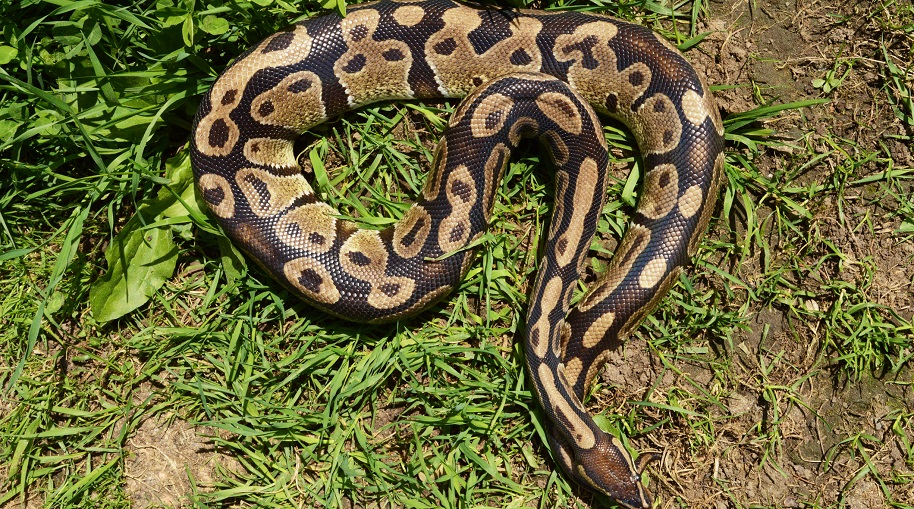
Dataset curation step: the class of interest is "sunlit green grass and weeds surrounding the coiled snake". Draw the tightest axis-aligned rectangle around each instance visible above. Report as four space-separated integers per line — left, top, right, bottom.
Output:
0 0 914 508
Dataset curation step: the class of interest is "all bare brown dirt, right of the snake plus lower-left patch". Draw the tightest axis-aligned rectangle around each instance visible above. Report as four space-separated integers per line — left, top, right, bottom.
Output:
121 0 914 508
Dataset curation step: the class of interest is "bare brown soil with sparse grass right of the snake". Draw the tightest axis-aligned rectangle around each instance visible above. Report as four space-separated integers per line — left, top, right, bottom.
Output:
595 0 914 508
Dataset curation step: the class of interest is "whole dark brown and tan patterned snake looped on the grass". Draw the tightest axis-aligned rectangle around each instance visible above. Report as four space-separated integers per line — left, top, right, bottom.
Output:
191 0 723 508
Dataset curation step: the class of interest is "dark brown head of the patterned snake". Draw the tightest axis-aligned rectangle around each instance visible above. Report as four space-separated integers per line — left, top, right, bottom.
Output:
551 433 660 509
